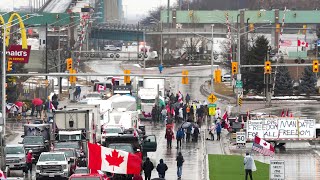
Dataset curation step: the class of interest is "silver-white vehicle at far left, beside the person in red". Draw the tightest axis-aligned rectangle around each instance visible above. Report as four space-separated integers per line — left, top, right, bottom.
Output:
5 144 26 170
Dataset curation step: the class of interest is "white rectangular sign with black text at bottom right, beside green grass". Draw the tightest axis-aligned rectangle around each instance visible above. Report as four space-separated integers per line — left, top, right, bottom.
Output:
269 160 285 180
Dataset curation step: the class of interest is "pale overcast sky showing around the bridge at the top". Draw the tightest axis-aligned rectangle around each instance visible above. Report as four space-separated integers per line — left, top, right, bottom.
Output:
0 0 176 20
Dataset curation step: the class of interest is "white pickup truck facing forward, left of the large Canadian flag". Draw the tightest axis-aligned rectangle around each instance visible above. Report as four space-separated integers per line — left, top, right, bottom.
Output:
36 152 70 180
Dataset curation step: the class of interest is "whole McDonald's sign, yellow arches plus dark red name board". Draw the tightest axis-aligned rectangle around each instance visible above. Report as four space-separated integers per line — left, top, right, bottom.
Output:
0 13 31 63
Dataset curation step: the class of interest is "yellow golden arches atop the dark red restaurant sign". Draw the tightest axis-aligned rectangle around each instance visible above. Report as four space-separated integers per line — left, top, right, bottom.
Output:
0 13 28 49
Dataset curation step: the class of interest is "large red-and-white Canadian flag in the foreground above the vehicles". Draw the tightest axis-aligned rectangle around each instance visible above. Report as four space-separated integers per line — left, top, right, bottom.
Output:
88 143 142 174
